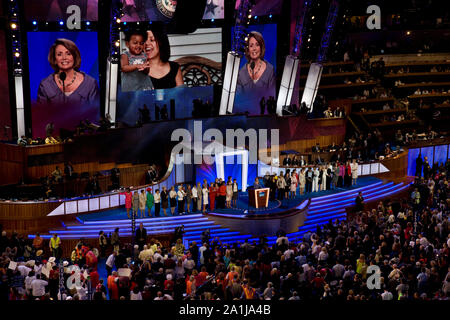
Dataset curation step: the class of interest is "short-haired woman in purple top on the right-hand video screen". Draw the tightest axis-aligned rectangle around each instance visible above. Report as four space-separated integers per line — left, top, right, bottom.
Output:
237 31 276 101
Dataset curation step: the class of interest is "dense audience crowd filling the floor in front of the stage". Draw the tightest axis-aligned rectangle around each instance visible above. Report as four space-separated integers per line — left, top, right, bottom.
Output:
0 157 450 301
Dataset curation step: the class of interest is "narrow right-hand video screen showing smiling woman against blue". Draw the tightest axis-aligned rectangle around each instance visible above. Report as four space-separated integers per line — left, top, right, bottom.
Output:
232 24 277 115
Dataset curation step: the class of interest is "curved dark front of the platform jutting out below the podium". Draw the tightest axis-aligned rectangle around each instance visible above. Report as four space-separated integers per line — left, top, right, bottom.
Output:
205 198 311 236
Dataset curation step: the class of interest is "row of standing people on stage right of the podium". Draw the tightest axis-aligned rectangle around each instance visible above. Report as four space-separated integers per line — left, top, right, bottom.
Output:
263 160 358 201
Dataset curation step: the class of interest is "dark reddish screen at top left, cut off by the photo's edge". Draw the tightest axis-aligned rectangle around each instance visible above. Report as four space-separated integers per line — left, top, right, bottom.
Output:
23 0 98 22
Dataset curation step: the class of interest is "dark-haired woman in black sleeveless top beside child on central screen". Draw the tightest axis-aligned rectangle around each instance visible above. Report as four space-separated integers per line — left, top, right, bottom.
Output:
145 28 184 89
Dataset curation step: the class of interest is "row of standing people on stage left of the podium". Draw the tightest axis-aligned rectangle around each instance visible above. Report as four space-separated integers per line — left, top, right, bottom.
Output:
120 177 238 218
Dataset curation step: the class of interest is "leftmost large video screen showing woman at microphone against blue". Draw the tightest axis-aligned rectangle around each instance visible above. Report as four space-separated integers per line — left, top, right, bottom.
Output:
27 32 100 138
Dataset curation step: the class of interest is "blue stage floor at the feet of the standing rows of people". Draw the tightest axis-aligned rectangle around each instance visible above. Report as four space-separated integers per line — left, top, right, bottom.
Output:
78 176 381 221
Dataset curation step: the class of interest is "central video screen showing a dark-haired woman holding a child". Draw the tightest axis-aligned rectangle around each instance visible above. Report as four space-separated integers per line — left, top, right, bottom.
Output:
117 22 222 125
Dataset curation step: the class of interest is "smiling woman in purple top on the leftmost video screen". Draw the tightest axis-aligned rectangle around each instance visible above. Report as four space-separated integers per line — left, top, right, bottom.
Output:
37 39 99 104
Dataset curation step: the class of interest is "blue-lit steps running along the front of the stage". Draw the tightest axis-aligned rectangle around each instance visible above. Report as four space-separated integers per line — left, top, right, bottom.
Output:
35 181 409 244
